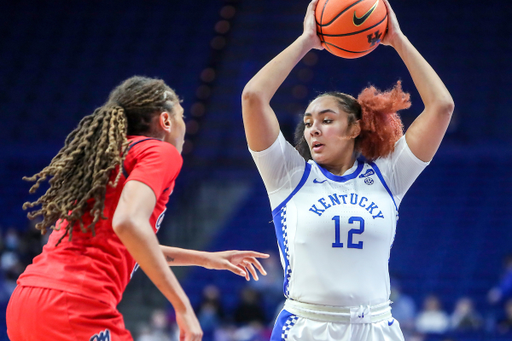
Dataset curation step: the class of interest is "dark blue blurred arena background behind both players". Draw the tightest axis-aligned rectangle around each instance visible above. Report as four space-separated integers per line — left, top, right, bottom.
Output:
0 0 512 340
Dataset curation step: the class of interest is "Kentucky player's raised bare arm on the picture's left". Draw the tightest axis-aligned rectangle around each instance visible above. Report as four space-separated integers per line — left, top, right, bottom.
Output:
242 0 322 151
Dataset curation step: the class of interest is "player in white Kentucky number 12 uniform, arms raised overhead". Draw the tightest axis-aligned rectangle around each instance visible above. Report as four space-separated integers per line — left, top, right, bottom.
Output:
242 0 454 341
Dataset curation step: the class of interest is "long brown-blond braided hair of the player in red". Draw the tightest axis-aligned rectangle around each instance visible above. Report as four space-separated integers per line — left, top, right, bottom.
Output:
23 76 179 242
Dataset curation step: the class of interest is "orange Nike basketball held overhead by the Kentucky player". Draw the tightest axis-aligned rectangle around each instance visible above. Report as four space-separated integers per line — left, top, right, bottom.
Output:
315 0 388 59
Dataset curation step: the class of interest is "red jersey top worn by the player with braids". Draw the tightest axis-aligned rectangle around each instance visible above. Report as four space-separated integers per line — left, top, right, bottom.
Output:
18 136 183 306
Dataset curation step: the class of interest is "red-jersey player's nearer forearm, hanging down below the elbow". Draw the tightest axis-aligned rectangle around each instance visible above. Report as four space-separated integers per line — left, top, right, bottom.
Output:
114 221 191 312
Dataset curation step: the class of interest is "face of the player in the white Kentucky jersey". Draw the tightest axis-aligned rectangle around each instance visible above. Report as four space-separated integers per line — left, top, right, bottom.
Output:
304 96 357 166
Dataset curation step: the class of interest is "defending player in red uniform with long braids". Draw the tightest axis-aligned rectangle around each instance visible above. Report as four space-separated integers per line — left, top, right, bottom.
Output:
7 77 267 341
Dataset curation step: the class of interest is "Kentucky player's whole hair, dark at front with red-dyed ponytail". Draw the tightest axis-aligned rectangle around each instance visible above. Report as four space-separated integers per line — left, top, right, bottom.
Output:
294 81 411 161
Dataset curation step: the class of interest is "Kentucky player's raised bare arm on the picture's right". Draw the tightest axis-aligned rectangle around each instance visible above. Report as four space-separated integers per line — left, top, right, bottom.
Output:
382 0 454 161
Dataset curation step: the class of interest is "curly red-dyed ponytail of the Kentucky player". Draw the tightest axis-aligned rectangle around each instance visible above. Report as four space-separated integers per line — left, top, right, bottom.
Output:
357 81 411 161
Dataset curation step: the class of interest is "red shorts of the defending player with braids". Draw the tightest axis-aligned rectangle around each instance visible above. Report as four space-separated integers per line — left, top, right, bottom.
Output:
6 286 133 341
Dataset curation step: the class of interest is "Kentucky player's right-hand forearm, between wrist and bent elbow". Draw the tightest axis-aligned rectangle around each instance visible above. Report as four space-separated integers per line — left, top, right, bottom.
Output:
394 34 453 110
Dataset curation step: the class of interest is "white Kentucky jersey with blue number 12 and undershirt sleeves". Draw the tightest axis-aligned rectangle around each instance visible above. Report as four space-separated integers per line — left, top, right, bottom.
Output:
251 130 427 306
